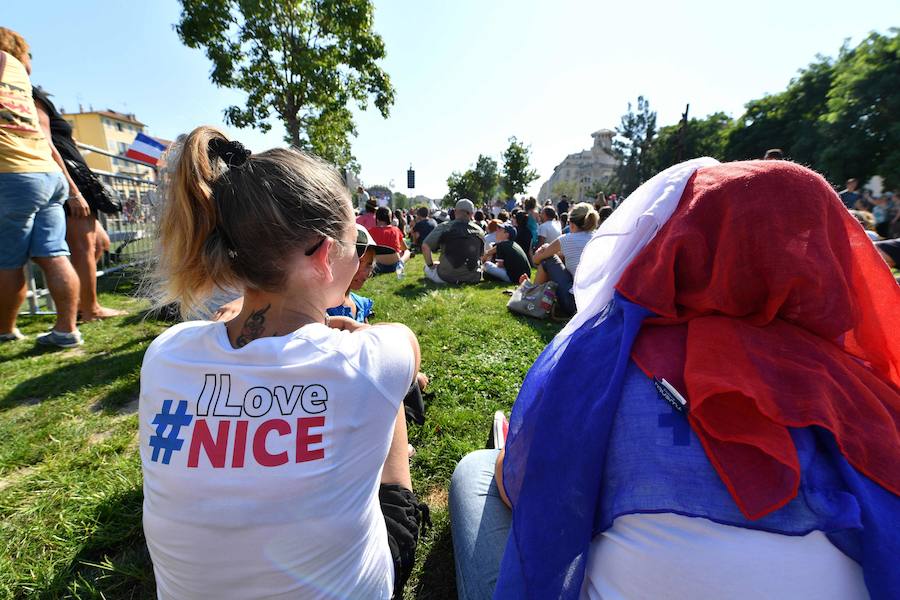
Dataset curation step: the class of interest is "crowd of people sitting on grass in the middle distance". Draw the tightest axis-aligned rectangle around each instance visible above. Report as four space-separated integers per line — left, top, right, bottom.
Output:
356 187 621 317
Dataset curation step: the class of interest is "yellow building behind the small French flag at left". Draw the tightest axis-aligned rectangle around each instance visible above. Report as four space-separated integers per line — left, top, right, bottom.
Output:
62 110 156 179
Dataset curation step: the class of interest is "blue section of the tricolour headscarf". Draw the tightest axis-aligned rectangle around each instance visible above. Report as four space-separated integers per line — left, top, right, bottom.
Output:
494 294 900 599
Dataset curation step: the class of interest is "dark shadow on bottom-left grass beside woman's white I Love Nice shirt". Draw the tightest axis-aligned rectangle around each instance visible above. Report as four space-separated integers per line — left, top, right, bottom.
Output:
40 488 156 598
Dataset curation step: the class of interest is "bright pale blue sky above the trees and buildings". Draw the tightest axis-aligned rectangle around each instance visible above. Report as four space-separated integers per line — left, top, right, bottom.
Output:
0 0 900 197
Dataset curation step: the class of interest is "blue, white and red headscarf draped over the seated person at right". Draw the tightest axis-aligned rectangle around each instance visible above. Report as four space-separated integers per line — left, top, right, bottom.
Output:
496 159 900 598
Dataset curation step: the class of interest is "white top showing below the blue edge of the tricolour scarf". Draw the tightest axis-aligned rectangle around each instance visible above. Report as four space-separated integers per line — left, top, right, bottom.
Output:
581 513 868 600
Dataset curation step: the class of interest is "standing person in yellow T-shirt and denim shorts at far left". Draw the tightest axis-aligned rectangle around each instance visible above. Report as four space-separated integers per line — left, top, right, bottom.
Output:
0 27 84 348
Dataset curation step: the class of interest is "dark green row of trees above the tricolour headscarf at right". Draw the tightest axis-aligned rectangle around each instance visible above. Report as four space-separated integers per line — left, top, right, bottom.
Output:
636 28 900 190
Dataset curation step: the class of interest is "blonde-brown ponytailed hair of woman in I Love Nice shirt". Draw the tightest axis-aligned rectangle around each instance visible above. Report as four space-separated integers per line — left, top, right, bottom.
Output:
153 126 353 315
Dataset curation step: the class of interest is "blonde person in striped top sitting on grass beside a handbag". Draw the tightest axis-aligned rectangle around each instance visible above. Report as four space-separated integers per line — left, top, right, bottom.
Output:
520 202 600 315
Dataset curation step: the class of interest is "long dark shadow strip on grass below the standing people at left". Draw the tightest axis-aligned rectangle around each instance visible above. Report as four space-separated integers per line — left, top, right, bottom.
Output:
0 338 146 412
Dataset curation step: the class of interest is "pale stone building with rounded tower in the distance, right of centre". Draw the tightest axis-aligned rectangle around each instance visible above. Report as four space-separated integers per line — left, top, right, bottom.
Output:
538 129 619 202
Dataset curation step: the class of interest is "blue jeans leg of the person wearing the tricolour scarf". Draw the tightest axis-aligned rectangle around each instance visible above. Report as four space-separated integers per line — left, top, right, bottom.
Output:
450 450 512 600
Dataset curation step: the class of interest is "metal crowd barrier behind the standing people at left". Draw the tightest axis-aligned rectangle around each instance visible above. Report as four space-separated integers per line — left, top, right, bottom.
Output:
22 144 159 315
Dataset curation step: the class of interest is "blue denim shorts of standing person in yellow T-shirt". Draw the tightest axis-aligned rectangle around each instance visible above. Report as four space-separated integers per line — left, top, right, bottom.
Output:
0 171 69 269
